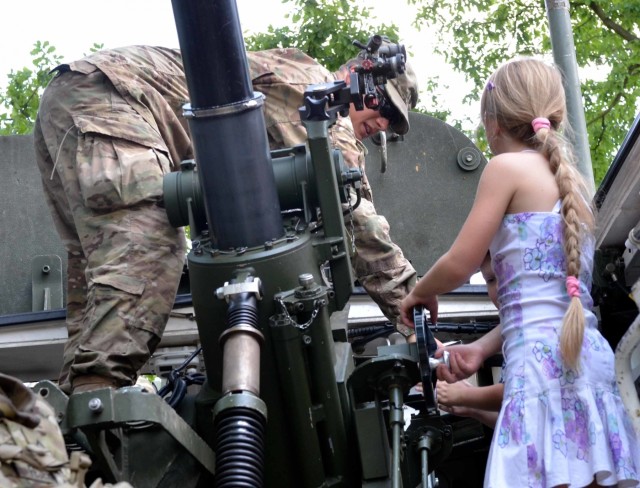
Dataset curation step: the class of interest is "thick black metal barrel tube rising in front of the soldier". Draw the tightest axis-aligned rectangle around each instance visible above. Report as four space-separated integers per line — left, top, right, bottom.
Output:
172 0 284 249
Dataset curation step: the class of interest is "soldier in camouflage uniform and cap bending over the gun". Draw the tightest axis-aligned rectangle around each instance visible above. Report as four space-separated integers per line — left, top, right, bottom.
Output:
34 41 417 392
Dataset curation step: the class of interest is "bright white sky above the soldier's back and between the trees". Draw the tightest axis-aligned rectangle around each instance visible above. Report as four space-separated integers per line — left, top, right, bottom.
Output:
0 0 477 122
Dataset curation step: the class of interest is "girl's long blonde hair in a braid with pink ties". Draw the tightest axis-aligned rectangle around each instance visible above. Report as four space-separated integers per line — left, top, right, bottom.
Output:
480 58 594 368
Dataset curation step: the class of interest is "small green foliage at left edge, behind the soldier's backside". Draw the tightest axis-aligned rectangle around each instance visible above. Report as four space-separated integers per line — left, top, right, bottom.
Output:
0 41 62 135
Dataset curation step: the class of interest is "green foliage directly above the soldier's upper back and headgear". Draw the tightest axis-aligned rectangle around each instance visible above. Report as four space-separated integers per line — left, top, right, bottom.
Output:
245 0 398 71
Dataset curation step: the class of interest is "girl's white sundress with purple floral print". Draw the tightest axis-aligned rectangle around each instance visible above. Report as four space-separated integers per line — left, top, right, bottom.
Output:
484 204 640 488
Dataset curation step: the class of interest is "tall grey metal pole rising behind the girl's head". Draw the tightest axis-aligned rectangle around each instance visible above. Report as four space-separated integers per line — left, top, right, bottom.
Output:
545 0 595 195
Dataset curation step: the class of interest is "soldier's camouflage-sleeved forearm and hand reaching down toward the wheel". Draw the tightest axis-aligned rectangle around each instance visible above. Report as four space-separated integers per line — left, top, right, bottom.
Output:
345 190 417 336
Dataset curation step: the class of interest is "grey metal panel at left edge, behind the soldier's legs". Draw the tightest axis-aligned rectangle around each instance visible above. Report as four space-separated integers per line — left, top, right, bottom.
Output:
0 135 67 315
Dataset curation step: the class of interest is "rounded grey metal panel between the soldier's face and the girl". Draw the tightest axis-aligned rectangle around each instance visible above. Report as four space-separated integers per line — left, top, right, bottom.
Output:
365 113 486 275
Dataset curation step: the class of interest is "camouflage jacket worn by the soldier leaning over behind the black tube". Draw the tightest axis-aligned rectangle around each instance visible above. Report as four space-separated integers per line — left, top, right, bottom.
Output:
63 46 416 332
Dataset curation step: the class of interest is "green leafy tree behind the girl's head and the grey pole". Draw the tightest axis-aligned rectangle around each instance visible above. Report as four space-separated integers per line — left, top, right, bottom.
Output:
409 0 640 184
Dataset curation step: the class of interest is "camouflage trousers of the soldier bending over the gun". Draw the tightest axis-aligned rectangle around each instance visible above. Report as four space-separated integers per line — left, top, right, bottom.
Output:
34 70 185 391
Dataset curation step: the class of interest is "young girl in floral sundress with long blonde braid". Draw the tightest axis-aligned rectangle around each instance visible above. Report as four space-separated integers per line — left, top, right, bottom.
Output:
401 59 640 488
